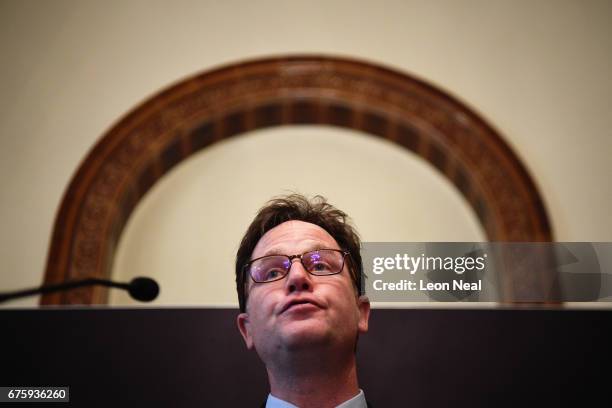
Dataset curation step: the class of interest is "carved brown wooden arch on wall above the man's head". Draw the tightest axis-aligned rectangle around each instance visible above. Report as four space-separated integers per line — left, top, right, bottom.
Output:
41 56 552 304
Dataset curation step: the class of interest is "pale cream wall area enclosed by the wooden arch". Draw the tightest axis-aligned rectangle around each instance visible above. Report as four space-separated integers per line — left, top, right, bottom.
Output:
111 126 485 305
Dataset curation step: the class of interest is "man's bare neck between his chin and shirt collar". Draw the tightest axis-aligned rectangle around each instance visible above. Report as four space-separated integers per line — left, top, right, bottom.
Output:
266 344 359 408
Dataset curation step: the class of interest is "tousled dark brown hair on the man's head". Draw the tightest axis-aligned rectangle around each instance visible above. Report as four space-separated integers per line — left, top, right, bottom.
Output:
236 194 363 312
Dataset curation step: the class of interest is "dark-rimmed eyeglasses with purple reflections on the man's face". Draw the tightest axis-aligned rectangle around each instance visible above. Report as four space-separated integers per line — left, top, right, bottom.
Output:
244 249 349 283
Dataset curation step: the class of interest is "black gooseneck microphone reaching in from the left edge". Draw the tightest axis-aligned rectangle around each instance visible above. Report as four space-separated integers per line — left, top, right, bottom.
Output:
0 277 159 303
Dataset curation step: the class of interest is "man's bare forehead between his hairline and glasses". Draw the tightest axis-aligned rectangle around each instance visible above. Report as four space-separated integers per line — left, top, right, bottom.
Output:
252 221 340 258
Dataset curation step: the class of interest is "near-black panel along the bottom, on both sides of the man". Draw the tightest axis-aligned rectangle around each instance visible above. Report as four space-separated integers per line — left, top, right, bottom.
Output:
0 308 612 408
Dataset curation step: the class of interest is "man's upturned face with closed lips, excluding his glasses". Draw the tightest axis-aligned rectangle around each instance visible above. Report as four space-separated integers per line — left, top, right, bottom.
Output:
237 221 370 361
